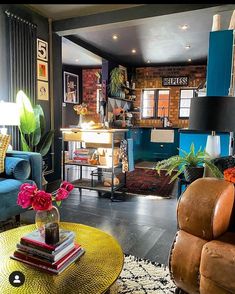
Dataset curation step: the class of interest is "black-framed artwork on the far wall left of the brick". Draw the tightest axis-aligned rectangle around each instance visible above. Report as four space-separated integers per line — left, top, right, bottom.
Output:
64 71 79 103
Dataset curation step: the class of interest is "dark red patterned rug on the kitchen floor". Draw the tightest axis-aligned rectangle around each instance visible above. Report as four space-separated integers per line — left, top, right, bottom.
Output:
120 168 175 198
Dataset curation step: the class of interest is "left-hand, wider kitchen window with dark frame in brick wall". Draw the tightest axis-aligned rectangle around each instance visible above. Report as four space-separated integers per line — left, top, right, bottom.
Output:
142 89 170 118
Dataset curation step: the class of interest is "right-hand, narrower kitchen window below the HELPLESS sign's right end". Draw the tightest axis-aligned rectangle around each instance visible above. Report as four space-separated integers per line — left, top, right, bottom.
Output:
179 89 196 118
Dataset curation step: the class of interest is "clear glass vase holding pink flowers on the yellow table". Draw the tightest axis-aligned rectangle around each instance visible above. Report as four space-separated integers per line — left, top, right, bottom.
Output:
35 206 60 238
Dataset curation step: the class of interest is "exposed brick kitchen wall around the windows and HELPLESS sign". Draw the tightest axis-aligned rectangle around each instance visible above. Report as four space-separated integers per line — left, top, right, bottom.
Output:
135 65 206 128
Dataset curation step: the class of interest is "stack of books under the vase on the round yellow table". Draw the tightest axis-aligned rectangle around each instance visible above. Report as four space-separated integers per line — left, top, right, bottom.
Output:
11 229 85 274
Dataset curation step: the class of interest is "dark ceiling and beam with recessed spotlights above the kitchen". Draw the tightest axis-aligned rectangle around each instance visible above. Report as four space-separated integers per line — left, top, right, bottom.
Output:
29 4 235 66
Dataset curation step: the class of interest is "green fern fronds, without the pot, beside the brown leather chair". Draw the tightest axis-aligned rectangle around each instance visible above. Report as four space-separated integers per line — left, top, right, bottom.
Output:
155 143 223 183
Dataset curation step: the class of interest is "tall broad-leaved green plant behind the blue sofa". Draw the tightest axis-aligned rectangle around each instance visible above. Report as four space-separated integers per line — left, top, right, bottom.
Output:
16 91 54 156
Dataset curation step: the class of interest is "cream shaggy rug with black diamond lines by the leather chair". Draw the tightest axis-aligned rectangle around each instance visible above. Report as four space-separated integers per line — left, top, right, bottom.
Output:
110 255 175 294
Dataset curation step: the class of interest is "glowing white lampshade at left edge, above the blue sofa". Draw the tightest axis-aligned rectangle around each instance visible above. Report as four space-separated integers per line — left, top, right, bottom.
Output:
0 101 20 126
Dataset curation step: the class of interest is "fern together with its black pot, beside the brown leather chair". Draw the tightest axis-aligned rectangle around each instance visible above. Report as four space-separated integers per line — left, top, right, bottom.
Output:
155 143 223 183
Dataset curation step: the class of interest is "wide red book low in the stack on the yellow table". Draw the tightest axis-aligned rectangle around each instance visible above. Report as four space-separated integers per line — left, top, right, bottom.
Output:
13 244 81 270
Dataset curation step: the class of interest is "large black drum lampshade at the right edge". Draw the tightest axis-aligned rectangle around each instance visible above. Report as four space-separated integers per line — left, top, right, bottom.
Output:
189 96 235 132
